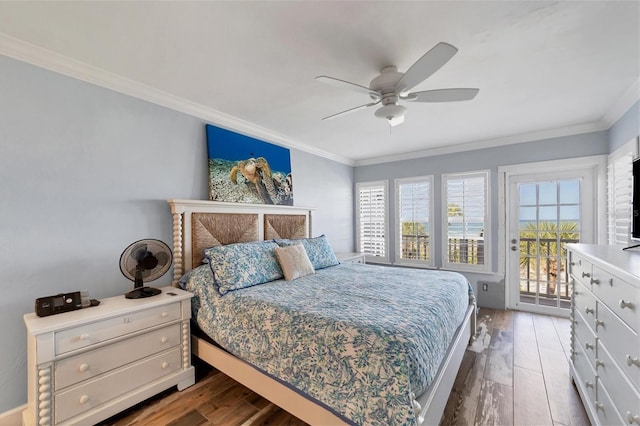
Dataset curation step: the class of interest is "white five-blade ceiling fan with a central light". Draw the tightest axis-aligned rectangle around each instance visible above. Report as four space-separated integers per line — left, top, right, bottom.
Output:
316 42 479 126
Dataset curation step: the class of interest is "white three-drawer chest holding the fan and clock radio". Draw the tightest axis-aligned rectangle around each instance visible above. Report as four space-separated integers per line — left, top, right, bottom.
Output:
23 287 195 425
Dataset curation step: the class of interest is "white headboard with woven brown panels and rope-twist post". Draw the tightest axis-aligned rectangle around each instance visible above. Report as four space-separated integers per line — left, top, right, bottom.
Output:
168 199 313 286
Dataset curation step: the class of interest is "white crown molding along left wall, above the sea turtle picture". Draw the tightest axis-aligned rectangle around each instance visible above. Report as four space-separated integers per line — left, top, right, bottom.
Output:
0 32 354 166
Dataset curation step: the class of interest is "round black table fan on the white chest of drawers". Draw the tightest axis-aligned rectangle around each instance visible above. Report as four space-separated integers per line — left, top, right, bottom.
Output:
120 239 173 299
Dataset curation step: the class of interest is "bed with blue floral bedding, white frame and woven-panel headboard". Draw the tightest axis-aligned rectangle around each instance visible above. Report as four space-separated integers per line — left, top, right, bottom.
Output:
169 200 475 425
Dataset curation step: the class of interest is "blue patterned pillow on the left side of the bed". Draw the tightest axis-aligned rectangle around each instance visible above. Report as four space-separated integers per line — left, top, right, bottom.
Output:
204 241 283 295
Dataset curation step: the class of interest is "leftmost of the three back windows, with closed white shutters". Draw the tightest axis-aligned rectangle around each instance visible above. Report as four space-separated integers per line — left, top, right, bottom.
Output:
356 180 389 262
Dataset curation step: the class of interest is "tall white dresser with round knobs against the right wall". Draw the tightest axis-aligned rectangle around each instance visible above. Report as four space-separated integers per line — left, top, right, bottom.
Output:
567 244 640 425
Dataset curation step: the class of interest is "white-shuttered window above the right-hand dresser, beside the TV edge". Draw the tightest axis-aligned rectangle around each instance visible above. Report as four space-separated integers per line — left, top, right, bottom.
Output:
607 140 636 245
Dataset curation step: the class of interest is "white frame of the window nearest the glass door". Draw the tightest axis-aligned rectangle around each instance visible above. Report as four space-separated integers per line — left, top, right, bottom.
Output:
441 169 492 272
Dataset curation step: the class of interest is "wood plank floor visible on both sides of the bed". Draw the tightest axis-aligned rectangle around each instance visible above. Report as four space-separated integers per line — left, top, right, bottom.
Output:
100 308 589 426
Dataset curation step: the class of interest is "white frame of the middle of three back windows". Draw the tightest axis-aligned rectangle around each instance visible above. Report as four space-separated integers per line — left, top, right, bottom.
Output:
394 175 436 268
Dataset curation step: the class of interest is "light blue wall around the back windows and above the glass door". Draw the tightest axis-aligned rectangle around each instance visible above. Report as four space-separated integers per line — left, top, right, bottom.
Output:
354 131 609 292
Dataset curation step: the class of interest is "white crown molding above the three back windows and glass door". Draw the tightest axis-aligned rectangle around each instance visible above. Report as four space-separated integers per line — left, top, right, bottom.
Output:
354 121 609 167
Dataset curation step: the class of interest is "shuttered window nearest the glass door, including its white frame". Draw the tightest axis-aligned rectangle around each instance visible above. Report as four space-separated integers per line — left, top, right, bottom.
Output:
442 171 491 271
